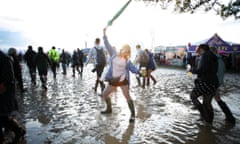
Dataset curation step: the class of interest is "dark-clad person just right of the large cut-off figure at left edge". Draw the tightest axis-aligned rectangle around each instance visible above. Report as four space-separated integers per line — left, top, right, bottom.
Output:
8 48 26 93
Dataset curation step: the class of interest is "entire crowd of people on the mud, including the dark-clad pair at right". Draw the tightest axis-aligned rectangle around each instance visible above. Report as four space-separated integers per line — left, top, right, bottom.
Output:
0 28 235 143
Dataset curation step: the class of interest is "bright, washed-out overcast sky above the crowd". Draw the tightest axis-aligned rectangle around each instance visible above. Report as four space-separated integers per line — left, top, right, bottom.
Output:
0 0 240 49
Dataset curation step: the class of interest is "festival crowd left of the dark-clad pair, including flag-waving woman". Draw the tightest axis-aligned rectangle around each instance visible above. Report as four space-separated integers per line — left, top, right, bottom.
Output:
0 29 157 143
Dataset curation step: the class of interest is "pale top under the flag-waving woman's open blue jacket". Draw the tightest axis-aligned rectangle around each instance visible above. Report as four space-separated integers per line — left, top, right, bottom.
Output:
112 56 127 81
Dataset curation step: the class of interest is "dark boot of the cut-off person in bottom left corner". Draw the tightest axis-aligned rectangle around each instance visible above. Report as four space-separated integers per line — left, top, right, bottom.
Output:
6 118 26 143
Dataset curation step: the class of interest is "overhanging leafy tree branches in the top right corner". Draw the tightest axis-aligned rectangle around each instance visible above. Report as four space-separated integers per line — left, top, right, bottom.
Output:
136 0 240 19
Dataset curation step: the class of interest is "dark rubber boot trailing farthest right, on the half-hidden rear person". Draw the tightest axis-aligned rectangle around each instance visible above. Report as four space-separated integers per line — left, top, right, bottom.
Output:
217 100 236 124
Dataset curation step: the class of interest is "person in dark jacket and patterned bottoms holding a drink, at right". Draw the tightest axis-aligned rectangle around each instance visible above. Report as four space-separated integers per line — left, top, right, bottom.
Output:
190 44 219 123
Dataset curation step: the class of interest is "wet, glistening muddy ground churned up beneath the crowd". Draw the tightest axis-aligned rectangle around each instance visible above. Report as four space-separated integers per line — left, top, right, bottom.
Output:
12 65 240 144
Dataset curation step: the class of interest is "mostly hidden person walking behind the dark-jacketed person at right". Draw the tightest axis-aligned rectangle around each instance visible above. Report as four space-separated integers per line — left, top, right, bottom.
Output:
210 47 236 124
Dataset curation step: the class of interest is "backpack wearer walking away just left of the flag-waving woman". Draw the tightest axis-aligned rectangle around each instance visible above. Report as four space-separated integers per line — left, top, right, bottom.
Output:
86 38 106 92
